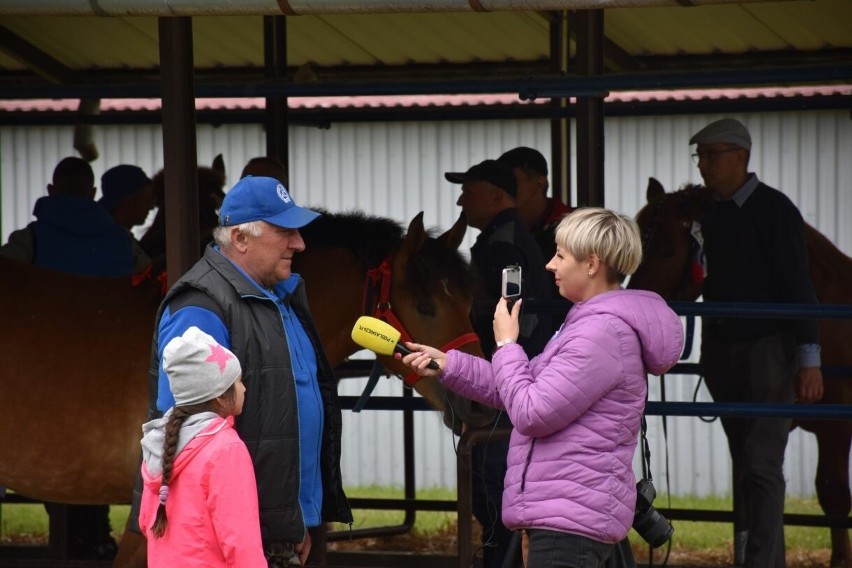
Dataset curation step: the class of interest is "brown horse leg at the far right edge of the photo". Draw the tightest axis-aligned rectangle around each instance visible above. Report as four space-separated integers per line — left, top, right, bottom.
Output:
808 420 852 568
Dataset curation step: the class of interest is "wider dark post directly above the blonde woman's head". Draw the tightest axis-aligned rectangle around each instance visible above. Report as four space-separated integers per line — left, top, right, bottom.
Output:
571 10 604 206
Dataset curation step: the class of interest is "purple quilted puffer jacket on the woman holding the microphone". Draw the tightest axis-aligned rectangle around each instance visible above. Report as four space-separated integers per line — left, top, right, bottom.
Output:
441 290 683 543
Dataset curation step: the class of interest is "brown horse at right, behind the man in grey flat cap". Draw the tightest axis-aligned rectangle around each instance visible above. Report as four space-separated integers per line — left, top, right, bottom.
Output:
629 178 852 568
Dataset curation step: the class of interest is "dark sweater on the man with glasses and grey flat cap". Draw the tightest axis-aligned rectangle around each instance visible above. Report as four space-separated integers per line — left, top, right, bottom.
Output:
701 183 819 345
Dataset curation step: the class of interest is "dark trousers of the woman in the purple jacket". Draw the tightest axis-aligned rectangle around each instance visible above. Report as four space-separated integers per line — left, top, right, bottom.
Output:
527 529 612 568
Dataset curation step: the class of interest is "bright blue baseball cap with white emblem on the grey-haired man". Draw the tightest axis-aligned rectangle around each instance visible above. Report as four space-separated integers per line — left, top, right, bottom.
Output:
219 176 320 229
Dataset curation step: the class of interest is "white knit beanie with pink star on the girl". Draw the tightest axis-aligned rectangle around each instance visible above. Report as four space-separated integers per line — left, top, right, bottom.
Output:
163 326 242 406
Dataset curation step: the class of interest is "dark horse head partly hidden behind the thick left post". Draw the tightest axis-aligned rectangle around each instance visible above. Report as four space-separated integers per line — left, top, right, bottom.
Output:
139 154 225 262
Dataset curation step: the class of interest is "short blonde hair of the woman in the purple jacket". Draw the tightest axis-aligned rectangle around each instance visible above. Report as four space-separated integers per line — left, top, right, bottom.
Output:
555 207 642 282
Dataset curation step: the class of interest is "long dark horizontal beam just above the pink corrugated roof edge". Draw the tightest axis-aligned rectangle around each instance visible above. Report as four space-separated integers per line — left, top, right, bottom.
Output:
0 49 852 99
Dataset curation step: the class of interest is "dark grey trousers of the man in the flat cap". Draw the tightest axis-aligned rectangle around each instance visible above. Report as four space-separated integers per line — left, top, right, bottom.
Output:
701 333 796 568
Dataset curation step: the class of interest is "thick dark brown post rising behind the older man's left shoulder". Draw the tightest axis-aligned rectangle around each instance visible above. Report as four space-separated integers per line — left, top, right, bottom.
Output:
158 17 201 286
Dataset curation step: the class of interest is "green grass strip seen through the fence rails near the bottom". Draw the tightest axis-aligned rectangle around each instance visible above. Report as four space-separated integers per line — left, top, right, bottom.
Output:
0 487 830 550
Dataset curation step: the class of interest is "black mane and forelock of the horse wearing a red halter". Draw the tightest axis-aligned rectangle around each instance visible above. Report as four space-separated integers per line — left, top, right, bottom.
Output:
299 208 471 297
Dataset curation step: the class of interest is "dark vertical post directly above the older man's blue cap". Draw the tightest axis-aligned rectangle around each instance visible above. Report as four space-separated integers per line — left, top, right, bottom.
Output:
263 16 290 172
